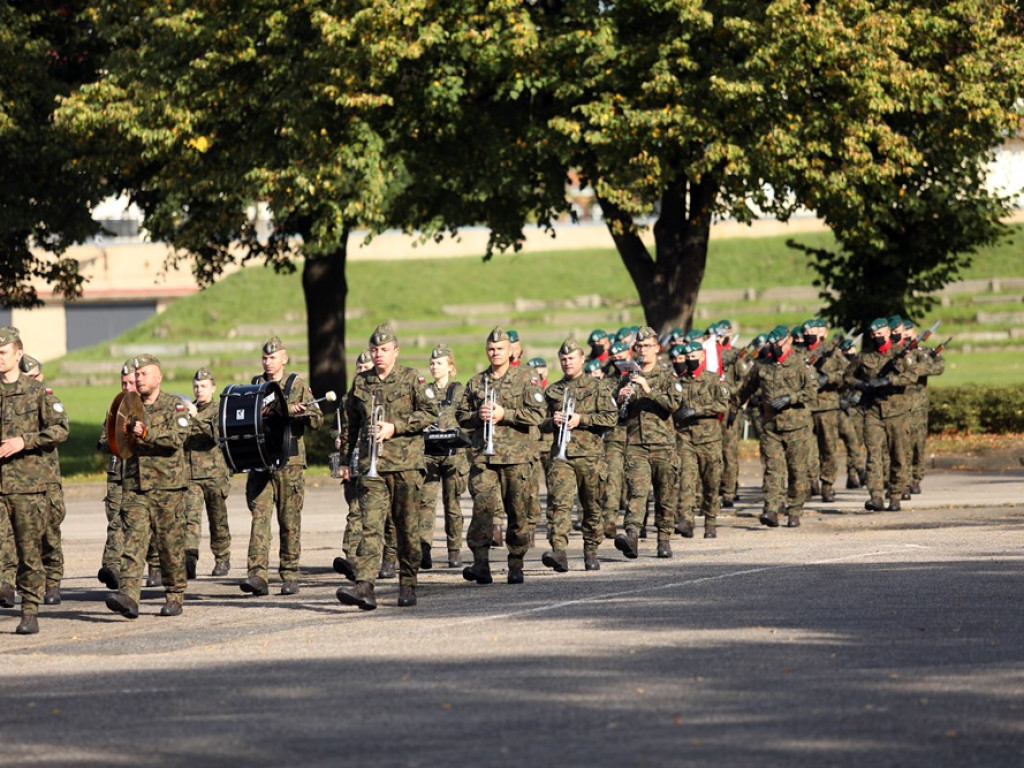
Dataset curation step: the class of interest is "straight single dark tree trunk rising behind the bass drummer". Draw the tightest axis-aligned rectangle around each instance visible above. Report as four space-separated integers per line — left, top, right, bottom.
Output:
302 234 348 403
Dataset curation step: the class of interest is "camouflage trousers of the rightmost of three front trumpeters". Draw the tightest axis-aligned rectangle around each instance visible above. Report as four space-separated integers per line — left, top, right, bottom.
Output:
547 456 607 552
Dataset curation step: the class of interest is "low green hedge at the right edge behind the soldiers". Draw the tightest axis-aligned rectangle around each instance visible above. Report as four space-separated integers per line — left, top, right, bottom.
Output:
928 384 1024 434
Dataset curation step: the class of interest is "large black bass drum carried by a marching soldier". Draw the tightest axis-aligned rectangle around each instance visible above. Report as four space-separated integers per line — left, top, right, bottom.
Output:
219 381 291 472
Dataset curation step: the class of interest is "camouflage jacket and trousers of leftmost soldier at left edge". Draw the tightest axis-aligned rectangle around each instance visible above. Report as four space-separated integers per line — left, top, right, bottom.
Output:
0 374 68 616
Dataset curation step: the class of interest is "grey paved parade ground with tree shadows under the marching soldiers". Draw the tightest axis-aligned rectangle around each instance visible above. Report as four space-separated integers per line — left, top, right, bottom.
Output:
0 466 1024 768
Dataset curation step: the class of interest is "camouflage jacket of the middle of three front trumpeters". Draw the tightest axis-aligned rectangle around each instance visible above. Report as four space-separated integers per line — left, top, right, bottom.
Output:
456 366 546 465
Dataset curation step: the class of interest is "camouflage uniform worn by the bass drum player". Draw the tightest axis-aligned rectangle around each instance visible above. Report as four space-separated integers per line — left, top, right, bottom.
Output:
246 374 324 582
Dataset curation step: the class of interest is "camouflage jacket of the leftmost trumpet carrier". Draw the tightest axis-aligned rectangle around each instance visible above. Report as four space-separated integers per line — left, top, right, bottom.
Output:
343 365 438 475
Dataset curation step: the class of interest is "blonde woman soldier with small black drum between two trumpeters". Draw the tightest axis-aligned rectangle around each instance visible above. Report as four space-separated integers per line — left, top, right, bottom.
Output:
420 344 469 570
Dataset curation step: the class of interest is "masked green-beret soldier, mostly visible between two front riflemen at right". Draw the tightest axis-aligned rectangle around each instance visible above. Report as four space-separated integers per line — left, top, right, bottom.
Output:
804 317 847 502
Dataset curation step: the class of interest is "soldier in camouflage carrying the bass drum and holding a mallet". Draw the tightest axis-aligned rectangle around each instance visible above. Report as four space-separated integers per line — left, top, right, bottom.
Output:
239 336 324 597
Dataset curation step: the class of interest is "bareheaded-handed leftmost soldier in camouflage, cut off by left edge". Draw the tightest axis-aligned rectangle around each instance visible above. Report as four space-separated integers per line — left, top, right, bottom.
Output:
0 327 68 635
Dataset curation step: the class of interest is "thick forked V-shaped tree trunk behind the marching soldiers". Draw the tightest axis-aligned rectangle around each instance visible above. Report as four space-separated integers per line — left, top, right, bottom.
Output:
598 178 718 333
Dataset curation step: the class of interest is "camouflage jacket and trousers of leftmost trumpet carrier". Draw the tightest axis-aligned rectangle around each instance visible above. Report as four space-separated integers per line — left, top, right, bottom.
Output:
345 364 437 587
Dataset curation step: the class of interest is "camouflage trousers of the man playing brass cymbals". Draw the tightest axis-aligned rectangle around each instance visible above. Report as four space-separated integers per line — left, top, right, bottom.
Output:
121 488 185 603
